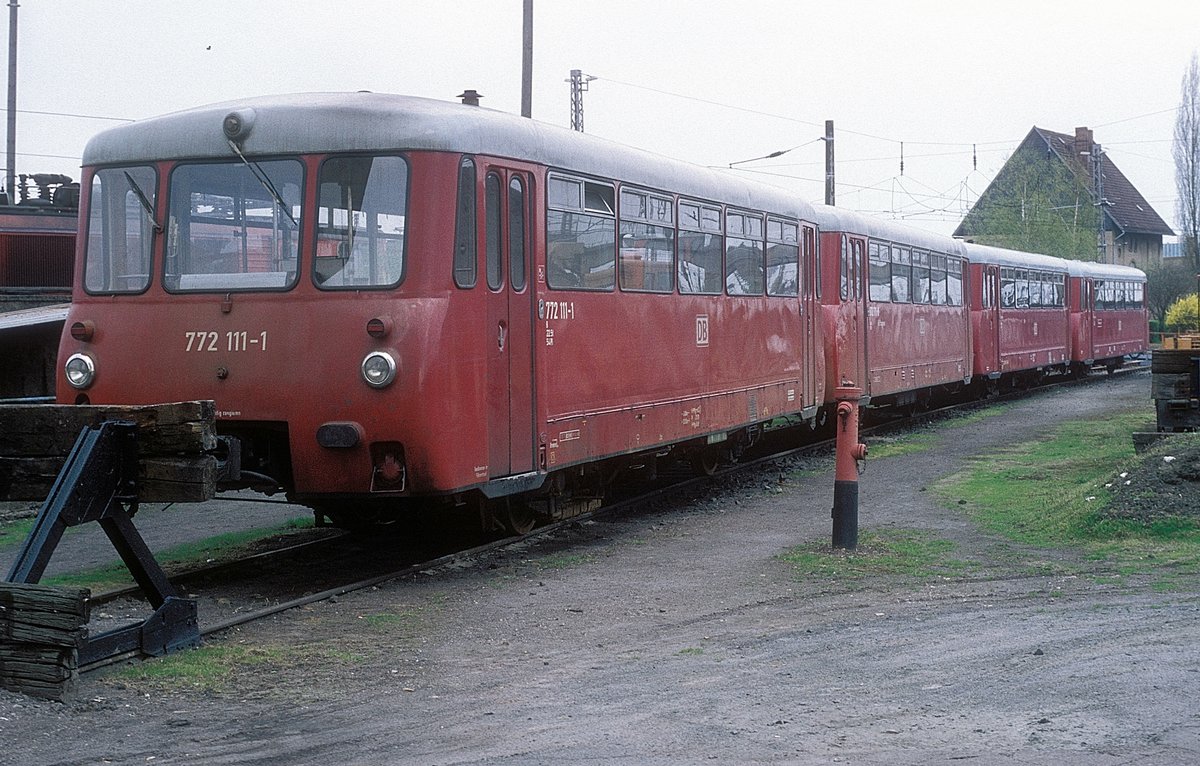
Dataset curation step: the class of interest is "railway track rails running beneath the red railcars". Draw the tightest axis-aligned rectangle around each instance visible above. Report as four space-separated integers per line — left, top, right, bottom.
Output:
80 367 1148 674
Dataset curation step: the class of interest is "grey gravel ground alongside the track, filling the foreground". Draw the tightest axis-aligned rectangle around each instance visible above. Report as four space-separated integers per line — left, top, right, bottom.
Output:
0 375 1200 766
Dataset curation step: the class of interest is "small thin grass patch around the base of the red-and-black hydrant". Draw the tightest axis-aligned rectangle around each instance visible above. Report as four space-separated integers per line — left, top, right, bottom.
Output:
780 528 973 582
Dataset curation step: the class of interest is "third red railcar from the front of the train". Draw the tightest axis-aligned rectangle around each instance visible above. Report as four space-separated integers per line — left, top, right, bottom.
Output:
965 243 1072 383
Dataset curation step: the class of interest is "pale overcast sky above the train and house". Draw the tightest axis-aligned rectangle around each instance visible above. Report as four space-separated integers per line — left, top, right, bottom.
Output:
0 0 1200 234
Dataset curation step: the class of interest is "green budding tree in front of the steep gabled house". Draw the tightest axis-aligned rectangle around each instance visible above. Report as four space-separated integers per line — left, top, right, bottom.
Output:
962 151 1099 261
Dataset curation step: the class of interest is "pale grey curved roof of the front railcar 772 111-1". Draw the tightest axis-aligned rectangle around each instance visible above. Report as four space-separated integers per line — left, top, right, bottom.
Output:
83 92 812 220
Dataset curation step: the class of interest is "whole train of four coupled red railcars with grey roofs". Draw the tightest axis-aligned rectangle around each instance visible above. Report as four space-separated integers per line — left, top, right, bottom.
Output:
51 92 1148 532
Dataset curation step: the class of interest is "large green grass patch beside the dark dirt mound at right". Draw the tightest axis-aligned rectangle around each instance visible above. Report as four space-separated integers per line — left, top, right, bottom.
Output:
934 408 1200 590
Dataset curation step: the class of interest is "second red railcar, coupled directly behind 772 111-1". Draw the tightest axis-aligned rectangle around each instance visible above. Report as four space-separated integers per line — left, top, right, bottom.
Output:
816 207 971 406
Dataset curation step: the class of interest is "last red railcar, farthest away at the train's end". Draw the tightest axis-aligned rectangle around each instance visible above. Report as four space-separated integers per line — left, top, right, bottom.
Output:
1067 261 1150 371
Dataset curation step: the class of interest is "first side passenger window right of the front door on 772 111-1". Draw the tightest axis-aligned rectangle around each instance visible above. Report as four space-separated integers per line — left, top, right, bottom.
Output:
546 175 617 291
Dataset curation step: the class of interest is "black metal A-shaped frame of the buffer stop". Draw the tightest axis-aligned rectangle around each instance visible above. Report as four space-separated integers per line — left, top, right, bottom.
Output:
7 420 200 664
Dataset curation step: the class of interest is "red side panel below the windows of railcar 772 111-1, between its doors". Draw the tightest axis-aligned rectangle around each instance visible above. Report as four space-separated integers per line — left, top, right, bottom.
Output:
536 290 820 468
